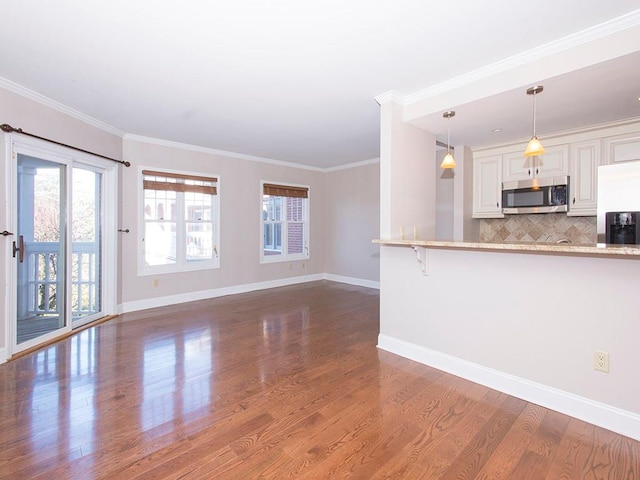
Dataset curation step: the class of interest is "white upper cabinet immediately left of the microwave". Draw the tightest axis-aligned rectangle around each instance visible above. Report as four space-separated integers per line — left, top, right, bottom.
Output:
473 155 504 218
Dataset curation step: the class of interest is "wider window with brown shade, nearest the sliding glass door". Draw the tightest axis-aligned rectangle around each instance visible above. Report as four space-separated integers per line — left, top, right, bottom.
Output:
140 170 219 274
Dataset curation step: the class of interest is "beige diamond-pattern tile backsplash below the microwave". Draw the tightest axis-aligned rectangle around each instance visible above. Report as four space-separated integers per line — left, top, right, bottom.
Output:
480 213 597 245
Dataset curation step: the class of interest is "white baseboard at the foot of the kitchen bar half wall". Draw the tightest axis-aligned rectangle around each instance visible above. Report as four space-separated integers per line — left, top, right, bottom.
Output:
378 334 640 440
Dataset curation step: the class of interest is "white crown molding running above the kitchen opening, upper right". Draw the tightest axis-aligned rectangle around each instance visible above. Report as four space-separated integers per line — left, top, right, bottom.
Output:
408 9 640 105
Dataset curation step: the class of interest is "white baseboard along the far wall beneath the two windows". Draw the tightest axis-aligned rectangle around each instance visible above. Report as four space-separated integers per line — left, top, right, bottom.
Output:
118 274 325 313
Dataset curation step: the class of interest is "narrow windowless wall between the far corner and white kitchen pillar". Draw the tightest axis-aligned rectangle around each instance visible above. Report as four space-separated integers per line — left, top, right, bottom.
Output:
325 162 380 286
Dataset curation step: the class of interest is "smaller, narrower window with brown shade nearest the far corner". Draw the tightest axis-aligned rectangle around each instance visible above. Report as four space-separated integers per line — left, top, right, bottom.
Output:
262 183 309 262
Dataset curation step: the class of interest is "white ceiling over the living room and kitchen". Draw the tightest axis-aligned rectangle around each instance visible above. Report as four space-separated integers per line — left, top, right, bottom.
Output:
0 0 640 168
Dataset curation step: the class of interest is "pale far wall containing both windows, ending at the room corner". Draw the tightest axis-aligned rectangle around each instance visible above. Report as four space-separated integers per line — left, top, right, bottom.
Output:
121 139 326 311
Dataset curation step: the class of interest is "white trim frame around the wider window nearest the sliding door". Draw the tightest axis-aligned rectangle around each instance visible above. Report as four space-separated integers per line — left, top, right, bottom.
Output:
136 165 222 277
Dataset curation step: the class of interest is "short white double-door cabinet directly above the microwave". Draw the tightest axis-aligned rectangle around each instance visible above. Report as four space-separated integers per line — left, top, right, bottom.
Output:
502 145 569 182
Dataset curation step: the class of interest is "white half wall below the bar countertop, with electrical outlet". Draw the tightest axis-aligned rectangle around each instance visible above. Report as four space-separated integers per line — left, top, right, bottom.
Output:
380 247 640 439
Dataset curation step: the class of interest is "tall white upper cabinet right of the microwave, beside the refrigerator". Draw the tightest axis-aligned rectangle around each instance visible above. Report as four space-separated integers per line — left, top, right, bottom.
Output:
567 140 602 217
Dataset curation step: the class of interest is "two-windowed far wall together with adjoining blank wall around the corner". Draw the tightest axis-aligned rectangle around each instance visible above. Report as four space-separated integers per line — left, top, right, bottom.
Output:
120 139 380 311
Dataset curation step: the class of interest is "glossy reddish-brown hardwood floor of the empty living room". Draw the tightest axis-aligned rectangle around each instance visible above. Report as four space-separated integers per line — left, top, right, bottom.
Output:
0 281 640 480
